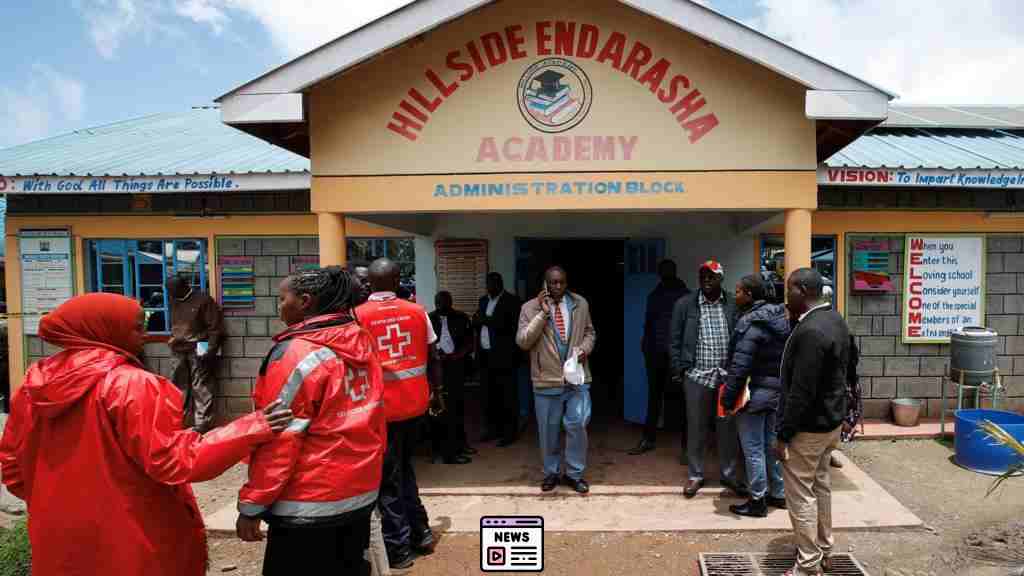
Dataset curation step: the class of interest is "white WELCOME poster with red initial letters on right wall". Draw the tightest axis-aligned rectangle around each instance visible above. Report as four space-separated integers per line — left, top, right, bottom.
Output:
903 234 985 343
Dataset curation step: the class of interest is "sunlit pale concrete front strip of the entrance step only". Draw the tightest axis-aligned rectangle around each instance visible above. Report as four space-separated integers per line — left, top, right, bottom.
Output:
205 455 923 535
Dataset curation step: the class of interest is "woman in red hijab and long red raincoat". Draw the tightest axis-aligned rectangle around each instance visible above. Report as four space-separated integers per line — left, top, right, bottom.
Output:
0 293 291 576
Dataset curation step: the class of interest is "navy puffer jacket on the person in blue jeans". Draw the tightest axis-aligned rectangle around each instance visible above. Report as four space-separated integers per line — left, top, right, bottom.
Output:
722 301 790 413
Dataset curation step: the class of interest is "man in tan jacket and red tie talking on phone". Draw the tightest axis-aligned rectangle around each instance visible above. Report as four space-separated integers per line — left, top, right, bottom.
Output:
516 266 597 494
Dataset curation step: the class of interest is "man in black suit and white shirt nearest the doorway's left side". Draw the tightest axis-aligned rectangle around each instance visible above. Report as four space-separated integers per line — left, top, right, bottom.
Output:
473 272 520 447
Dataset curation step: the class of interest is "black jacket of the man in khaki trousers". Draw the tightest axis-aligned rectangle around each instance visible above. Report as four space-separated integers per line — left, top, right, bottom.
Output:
778 307 850 442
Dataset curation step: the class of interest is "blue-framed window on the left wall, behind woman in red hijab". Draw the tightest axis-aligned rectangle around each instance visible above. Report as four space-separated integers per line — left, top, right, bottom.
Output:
86 240 208 332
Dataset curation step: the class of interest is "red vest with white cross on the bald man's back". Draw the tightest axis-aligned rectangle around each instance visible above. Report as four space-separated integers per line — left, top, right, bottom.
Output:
355 295 430 422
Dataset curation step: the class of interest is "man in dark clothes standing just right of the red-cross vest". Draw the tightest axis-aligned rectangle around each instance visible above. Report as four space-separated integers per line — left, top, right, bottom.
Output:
430 290 476 464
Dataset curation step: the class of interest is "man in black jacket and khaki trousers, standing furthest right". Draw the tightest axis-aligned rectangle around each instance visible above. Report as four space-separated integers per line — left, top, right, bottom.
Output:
775 269 850 576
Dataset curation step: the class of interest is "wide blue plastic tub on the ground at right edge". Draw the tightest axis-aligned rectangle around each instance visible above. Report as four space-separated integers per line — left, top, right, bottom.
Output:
954 410 1024 476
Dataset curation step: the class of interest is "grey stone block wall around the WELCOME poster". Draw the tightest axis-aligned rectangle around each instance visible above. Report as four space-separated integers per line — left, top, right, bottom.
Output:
846 235 1024 418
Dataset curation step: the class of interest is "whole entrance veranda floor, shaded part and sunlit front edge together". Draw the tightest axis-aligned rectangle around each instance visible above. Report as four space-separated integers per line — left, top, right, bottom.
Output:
206 412 922 534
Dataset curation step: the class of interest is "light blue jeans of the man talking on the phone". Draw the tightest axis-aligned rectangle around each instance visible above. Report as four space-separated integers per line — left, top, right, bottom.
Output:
534 384 591 480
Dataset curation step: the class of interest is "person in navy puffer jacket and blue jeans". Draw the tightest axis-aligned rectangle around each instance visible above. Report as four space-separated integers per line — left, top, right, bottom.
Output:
722 275 790 518
